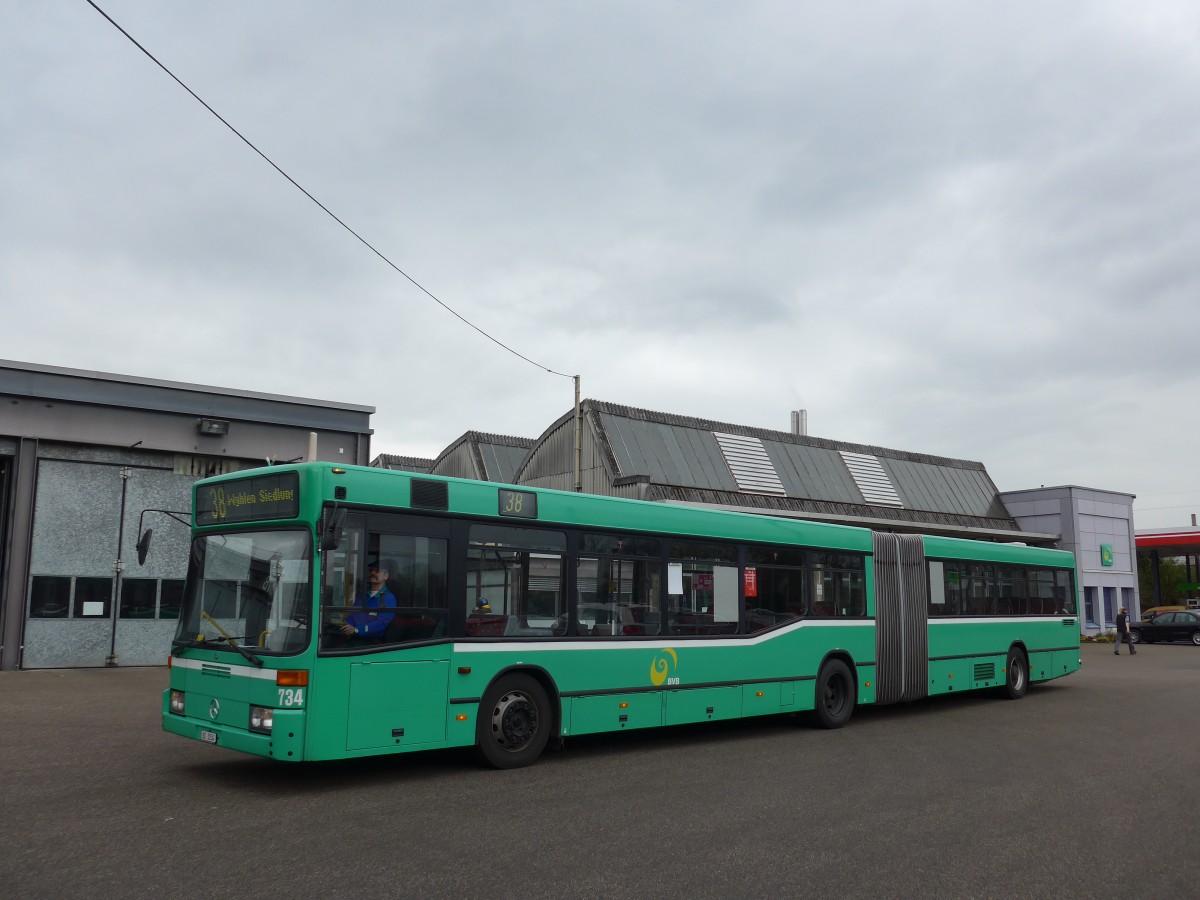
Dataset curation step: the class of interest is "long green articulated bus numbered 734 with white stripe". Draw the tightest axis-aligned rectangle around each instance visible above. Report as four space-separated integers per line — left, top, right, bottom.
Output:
162 463 1080 768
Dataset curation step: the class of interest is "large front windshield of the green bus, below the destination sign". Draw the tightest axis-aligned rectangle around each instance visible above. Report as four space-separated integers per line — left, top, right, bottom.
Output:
175 530 312 654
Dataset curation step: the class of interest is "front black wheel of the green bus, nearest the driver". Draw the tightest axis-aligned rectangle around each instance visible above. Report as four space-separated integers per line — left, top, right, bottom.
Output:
475 674 554 769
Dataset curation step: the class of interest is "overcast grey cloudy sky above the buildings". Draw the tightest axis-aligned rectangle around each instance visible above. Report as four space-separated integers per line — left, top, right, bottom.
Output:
7 0 1200 528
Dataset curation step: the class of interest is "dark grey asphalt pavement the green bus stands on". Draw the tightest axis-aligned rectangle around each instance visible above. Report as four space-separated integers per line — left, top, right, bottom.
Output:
0 644 1200 900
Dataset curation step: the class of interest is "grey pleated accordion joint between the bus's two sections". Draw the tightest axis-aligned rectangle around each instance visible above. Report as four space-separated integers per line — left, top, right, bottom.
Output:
874 532 929 703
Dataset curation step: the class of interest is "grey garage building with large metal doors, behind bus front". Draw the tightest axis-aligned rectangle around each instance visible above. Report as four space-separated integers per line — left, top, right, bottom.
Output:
0 360 374 670
